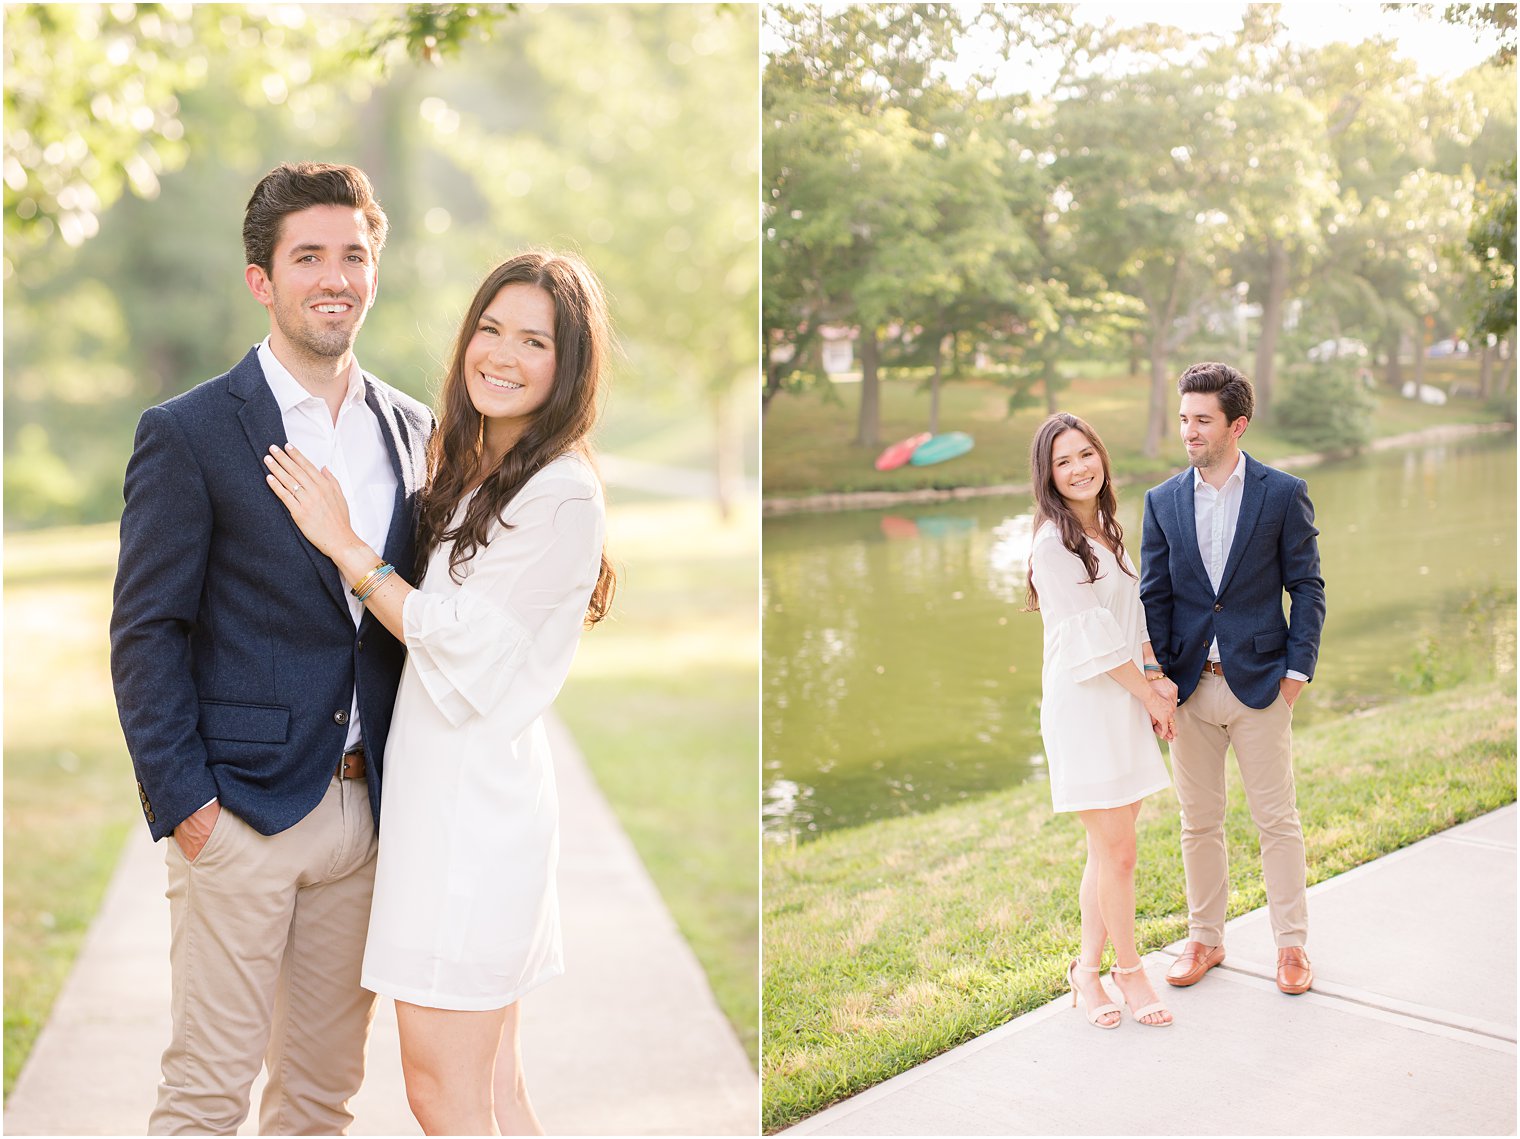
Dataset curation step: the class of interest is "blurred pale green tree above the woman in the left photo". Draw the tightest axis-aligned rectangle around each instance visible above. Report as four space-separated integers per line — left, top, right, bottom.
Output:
407 6 760 509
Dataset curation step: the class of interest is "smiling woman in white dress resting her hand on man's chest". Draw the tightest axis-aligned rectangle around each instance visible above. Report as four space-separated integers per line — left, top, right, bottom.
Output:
269 252 616 1134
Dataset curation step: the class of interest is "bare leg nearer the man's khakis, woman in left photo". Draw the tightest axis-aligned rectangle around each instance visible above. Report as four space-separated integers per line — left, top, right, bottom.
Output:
395 1001 506 1134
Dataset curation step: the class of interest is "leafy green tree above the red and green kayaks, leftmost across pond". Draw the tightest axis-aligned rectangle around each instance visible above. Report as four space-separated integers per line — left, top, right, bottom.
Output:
763 5 1064 447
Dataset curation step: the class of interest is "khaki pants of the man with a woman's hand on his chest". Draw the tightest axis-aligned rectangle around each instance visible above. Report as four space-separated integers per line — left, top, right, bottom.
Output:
147 779 375 1134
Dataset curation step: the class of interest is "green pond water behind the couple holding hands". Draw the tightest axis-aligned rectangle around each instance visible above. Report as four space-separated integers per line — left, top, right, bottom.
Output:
763 435 1515 839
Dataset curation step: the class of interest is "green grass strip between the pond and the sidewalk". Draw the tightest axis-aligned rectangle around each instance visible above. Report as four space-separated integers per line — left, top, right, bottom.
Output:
762 671 1515 1131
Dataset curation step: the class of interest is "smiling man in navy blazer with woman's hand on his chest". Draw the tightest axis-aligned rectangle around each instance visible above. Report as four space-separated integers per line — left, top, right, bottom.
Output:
111 163 432 1134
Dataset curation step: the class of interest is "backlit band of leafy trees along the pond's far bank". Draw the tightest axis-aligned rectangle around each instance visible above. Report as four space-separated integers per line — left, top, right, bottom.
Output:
763 5 1515 458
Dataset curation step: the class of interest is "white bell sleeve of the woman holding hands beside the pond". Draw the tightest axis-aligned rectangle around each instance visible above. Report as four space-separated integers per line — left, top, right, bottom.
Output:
1029 535 1134 683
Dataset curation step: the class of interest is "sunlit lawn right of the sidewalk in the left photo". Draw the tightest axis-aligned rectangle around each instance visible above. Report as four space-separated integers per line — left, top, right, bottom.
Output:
556 502 760 1060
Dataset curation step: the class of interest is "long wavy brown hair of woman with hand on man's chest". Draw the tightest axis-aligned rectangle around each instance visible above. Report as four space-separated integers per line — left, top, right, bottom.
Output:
416 251 617 625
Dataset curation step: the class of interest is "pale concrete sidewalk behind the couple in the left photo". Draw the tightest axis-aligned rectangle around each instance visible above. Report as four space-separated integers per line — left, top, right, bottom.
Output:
5 721 760 1134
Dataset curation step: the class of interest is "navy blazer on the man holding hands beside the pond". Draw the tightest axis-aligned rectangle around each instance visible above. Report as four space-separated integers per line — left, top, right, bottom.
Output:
1140 455 1325 709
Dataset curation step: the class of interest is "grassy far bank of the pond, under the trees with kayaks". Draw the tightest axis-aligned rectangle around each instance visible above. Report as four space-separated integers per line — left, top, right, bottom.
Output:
763 360 1497 499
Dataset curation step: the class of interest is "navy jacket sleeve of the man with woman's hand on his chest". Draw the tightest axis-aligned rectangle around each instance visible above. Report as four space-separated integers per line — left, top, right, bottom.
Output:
111 408 217 839
